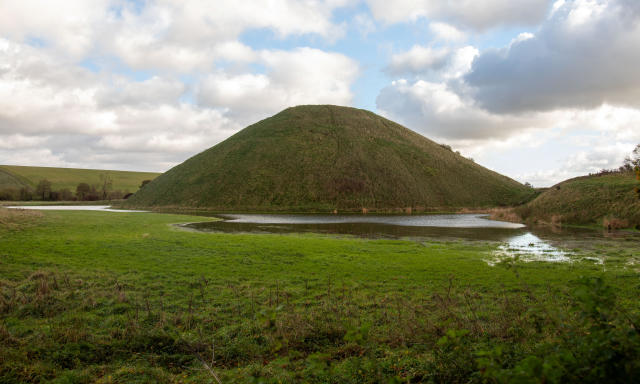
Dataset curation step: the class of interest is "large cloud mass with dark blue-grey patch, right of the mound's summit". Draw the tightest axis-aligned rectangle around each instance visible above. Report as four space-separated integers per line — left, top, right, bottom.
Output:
377 0 640 186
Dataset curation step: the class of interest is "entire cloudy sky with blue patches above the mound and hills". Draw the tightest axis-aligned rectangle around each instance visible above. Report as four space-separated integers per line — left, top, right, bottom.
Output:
0 0 640 186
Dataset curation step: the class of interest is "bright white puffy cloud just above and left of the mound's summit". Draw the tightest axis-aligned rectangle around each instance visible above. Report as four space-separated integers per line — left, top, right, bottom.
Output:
198 48 359 123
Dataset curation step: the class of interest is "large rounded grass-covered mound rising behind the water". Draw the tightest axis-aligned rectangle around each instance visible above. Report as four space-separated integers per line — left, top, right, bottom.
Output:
127 105 532 211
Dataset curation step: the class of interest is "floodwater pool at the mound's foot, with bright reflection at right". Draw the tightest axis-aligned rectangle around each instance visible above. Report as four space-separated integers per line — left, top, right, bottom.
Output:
181 214 640 264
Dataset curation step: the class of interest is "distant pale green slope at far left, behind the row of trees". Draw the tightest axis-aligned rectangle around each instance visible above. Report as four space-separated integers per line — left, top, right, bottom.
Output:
0 165 158 192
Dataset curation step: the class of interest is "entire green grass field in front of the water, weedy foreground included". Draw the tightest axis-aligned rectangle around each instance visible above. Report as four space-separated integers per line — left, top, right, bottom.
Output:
0 211 640 383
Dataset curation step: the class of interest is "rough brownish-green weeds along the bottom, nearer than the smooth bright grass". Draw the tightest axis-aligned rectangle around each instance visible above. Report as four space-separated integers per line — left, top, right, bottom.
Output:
0 265 640 383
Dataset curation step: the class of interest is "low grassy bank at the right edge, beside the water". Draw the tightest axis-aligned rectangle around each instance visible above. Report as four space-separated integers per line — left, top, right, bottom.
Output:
516 172 640 226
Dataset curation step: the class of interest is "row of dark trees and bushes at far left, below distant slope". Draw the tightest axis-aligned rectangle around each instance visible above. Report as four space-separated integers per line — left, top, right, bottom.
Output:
0 173 151 201
